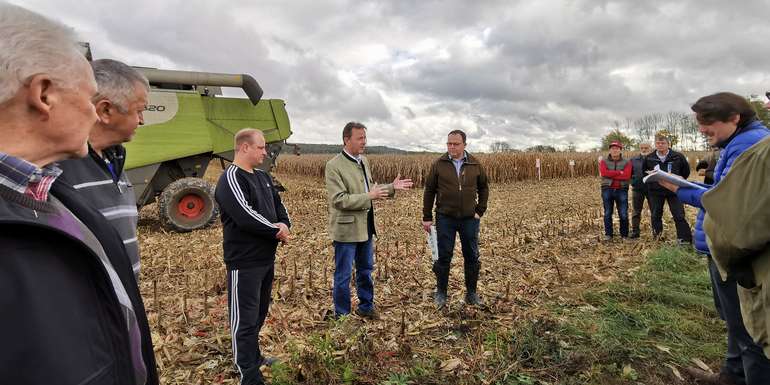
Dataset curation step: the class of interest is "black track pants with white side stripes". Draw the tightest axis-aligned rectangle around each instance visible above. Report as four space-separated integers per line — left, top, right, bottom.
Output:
227 264 274 385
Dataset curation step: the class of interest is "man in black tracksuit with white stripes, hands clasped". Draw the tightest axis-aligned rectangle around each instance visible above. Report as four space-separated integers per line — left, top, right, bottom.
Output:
215 129 291 385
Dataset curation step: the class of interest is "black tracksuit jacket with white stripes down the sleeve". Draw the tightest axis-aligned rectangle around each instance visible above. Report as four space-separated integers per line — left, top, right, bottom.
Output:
214 165 291 270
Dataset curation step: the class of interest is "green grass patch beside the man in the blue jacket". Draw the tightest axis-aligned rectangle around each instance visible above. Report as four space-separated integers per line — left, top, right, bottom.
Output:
510 247 725 384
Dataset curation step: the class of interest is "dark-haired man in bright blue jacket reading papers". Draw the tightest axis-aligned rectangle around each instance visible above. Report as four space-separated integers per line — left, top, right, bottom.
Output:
659 92 770 385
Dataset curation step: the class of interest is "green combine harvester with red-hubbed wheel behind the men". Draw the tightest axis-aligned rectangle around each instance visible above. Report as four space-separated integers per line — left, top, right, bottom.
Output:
125 67 291 232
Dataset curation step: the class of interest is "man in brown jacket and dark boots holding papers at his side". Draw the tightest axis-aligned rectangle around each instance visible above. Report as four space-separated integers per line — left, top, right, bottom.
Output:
422 130 489 308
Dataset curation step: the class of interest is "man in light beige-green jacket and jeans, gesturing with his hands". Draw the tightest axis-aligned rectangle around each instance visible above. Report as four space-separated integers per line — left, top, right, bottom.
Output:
325 122 412 319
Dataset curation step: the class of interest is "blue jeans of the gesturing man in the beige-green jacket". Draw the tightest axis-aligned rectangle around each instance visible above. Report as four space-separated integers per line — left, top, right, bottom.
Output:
332 235 374 315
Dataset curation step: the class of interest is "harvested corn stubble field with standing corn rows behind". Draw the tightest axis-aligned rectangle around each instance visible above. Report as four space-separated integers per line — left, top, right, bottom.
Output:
139 154 704 384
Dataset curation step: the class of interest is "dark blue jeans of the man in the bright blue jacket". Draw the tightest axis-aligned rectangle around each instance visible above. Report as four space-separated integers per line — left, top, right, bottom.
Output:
709 258 770 385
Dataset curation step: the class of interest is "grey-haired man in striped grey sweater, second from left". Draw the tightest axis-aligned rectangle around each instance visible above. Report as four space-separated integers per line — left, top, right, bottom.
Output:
59 59 150 280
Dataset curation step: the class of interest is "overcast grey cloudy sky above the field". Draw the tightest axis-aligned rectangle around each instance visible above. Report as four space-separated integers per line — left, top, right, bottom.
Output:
11 0 770 151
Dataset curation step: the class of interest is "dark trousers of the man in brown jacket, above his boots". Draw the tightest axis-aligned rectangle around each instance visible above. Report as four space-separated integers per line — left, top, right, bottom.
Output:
436 213 480 275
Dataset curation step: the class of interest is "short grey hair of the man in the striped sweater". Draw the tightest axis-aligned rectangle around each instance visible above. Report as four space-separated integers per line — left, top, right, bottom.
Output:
91 59 150 114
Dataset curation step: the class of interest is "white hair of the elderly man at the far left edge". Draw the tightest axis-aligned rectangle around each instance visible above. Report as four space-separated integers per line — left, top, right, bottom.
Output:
0 2 88 103
